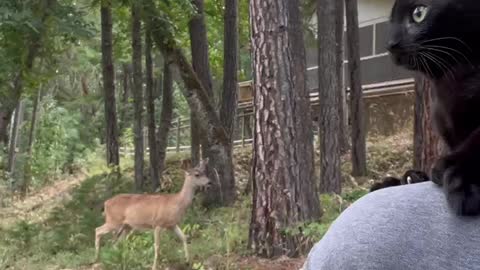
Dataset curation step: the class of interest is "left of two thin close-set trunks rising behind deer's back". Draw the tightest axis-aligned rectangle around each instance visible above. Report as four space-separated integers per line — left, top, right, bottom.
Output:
132 3 144 192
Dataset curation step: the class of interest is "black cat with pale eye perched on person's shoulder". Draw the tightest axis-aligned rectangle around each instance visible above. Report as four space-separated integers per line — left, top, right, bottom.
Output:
387 0 480 215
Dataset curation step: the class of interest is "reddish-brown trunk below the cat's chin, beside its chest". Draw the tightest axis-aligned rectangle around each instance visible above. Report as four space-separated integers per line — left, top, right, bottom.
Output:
413 75 445 173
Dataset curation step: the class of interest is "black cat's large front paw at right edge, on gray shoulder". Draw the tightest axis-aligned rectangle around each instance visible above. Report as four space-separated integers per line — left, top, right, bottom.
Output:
443 165 480 216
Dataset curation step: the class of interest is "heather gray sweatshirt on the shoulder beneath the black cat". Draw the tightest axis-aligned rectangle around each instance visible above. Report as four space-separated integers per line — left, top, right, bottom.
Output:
304 182 480 270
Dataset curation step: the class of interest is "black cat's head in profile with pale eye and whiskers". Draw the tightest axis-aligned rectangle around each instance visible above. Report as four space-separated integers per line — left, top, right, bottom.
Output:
387 0 480 78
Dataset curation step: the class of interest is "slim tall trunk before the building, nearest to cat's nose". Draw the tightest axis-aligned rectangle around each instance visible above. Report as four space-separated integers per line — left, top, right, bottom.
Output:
345 0 367 176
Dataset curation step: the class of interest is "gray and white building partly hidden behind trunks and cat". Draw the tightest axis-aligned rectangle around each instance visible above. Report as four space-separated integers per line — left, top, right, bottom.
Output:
239 0 414 139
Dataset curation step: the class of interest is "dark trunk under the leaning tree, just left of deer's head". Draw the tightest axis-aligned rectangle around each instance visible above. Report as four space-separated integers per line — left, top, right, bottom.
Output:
157 60 173 178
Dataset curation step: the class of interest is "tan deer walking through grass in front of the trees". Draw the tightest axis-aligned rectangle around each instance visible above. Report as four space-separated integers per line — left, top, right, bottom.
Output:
95 158 210 270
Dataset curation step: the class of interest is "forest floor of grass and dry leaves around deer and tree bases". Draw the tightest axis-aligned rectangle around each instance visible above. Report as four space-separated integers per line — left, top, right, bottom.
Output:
0 130 411 270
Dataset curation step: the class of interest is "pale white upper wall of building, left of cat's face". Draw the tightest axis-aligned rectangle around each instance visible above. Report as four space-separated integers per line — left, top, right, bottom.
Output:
358 0 395 26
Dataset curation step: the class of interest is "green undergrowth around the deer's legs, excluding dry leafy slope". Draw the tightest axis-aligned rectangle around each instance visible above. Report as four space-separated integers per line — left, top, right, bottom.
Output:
0 170 364 270
